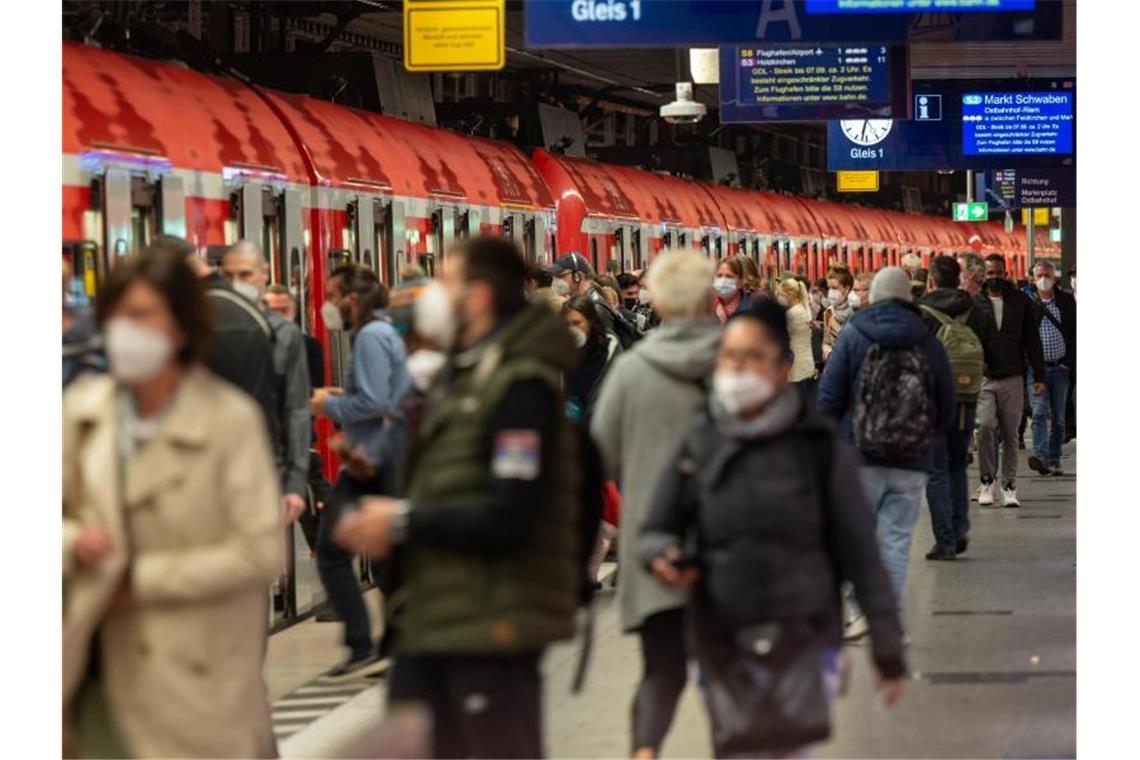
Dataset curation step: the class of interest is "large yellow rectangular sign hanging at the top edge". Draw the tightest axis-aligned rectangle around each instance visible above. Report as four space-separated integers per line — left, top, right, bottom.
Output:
404 0 506 72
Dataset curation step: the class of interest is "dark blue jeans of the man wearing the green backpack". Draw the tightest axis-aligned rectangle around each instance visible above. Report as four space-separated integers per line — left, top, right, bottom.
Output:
927 402 977 550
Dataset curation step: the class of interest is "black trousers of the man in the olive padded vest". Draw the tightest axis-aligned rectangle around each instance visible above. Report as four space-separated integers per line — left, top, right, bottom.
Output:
388 652 543 758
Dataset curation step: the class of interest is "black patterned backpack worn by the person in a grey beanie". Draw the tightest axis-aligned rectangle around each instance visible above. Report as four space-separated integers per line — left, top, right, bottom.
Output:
852 343 937 459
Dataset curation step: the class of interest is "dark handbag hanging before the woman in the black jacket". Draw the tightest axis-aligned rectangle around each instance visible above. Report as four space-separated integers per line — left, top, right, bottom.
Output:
702 621 831 755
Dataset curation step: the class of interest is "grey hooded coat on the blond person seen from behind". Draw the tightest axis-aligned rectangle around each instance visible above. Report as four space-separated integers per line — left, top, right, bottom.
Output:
589 319 720 631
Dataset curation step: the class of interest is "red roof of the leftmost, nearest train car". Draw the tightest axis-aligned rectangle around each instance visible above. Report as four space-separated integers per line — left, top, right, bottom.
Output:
63 42 308 182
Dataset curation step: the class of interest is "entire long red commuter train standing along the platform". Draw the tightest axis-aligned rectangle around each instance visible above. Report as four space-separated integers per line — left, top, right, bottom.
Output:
63 43 1059 389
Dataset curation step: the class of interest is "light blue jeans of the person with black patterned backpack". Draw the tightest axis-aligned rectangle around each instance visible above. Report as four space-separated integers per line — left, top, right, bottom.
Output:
858 466 927 608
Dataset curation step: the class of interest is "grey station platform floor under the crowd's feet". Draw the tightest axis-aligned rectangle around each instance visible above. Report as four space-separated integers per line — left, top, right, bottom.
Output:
267 442 1076 758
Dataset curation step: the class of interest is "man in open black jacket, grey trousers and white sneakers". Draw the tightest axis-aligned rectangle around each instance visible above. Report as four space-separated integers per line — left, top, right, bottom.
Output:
976 253 1045 507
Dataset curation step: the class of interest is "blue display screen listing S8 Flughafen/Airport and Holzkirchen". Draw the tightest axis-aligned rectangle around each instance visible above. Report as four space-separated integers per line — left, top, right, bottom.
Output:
720 43 906 123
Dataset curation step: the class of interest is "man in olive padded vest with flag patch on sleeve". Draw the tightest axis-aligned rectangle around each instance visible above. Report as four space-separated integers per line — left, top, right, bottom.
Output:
336 237 580 758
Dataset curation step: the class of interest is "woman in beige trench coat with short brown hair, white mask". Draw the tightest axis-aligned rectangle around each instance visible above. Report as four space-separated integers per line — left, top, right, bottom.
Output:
63 248 282 758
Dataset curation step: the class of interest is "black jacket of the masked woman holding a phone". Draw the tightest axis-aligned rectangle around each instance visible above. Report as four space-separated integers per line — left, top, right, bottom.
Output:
638 389 905 678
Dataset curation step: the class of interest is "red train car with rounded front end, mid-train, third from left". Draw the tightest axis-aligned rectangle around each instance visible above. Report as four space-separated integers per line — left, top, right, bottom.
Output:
531 149 728 271
